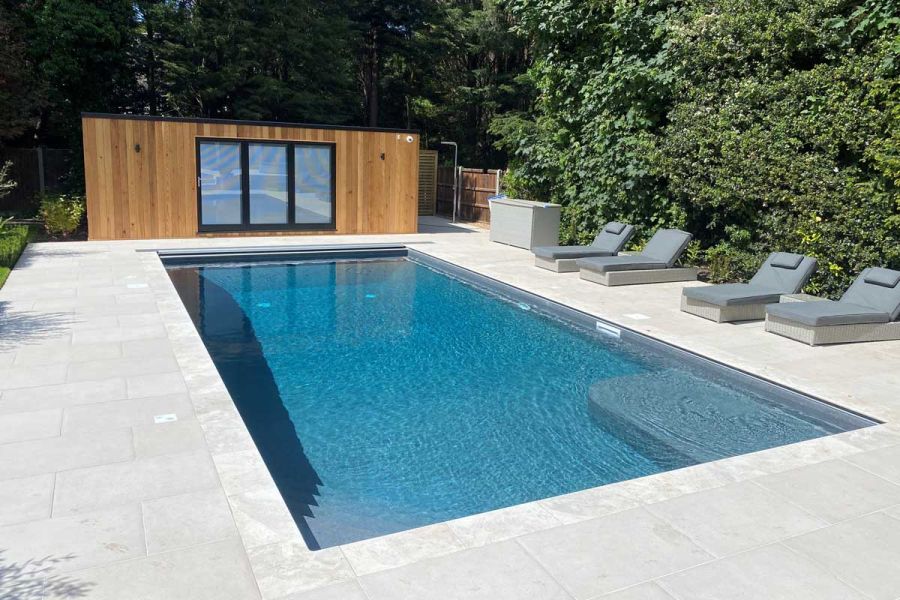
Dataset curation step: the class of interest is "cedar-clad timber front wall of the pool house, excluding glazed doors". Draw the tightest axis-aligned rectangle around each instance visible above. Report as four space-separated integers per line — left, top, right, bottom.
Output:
82 115 419 240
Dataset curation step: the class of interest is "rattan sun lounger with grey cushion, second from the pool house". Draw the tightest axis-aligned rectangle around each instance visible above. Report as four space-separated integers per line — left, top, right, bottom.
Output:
576 229 697 286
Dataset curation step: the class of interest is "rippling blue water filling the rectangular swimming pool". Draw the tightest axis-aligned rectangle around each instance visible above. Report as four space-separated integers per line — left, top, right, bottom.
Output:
170 253 871 548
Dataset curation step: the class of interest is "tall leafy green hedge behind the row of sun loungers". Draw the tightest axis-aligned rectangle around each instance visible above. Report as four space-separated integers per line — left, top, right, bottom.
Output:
494 0 900 296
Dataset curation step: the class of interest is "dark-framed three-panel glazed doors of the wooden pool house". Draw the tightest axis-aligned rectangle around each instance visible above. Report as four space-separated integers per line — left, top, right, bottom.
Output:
197 138 335 231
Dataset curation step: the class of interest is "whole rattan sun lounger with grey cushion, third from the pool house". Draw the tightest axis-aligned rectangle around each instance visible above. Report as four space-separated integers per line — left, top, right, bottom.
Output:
681 252 816 323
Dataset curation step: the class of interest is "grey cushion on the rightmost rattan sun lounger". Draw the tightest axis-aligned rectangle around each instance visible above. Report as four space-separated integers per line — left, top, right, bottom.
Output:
766 267 900 327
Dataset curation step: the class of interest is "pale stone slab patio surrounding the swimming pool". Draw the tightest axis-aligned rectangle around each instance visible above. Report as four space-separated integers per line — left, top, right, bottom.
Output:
0 219 900 600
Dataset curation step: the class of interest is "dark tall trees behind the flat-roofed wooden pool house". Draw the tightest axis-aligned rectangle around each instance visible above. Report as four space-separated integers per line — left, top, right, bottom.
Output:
0 0 527 166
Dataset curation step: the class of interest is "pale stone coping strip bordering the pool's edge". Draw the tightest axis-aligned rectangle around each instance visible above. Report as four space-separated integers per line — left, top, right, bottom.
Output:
142 241 900 598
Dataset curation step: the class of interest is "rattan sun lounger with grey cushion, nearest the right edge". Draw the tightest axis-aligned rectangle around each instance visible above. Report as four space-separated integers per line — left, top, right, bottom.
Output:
766 268 900 346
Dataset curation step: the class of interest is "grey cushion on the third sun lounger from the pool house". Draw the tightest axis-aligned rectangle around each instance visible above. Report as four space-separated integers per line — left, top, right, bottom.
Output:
684 252 816 306
